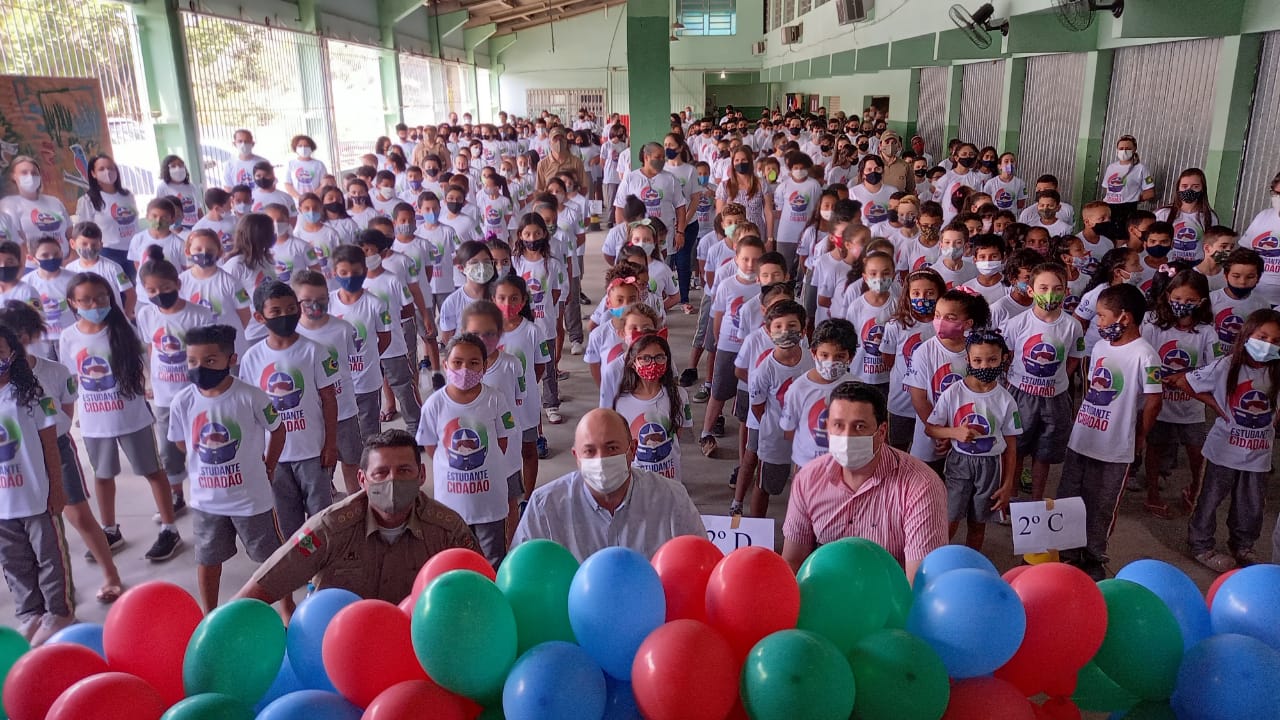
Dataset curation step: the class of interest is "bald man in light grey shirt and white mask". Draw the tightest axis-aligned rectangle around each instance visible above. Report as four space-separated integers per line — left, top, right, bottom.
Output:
511 407 707 561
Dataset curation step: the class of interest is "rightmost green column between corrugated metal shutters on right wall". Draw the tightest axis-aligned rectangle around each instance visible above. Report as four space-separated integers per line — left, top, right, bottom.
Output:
1204 35 1262 225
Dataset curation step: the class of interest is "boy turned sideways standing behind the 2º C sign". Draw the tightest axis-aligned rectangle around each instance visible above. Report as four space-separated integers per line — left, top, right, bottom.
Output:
1057 284 1161 580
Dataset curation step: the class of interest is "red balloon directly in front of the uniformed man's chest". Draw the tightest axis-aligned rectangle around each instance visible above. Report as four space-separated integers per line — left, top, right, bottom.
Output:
320 600 426 707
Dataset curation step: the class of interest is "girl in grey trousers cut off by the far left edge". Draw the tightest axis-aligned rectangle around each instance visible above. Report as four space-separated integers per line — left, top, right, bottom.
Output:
0 325 76 646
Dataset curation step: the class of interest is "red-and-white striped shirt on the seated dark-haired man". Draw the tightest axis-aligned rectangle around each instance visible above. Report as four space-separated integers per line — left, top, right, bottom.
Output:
782 445 947 564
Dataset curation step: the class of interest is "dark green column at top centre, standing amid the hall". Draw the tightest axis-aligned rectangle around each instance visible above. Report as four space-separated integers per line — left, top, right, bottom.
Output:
627 0 671 168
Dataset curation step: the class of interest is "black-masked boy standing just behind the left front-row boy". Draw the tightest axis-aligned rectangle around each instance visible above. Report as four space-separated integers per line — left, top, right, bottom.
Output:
238 281 338 537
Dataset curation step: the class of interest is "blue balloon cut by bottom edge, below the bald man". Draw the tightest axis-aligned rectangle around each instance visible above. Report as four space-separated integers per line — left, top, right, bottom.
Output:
502 641 605 720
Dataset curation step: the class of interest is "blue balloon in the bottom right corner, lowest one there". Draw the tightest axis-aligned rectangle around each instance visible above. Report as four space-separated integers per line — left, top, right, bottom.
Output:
1170 632 1280 720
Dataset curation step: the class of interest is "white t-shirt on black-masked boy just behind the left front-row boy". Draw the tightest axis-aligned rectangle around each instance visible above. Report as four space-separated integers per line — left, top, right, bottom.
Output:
235 337 338 462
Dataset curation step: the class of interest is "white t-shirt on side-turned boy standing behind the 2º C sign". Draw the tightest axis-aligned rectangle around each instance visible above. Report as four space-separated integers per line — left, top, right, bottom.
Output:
1066 337 1167 462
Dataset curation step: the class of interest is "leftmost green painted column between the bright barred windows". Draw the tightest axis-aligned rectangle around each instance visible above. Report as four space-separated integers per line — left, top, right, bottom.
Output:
133 0 202 184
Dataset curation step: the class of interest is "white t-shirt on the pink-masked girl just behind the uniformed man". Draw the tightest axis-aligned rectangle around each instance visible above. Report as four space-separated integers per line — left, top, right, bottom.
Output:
417 386 520 525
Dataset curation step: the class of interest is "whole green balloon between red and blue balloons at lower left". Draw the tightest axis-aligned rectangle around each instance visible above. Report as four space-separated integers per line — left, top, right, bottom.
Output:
182 597 284 705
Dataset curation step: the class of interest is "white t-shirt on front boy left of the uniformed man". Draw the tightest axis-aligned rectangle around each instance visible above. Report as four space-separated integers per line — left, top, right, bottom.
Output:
166 378 280 518
